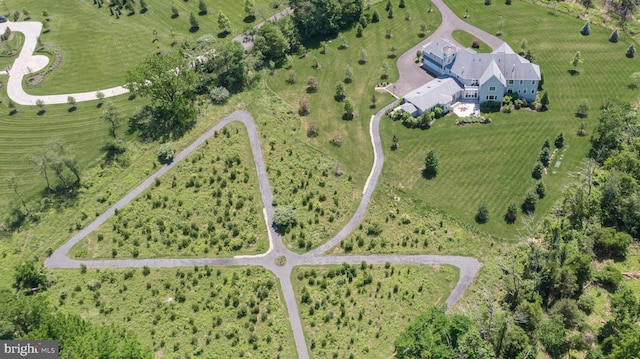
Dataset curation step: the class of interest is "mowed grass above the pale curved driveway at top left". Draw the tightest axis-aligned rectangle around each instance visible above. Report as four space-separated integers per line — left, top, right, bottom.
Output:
12 0 279 95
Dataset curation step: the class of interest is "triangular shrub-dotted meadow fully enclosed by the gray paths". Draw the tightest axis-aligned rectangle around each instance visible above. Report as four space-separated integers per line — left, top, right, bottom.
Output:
70 123 269 258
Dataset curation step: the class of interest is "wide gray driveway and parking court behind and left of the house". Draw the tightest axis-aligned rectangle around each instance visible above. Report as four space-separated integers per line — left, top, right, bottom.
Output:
389 0 503 97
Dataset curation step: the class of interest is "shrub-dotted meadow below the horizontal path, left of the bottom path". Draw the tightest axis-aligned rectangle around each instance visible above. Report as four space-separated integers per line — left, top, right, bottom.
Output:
46 266 296 358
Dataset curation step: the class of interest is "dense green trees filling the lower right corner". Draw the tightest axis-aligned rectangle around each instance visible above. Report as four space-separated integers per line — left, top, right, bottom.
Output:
395 99 640 359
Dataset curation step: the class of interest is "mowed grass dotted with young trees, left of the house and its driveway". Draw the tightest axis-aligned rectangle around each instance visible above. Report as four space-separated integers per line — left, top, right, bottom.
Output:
268 0 441 181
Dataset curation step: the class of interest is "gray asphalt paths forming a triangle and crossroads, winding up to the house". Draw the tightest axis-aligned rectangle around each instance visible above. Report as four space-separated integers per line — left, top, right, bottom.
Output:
36 0 510 359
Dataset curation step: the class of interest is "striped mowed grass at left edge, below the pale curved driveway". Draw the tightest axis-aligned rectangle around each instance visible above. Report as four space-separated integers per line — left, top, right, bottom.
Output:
0 94 146 208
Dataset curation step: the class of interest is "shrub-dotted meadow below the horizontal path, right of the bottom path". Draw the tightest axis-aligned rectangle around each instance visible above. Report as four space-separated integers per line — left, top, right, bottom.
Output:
291 264 458 358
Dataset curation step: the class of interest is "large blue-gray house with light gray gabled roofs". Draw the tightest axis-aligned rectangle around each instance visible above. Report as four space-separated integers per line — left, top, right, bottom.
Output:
404 39 540 116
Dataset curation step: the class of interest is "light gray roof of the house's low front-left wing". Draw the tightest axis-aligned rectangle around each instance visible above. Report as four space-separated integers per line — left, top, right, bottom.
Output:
404 78 462 112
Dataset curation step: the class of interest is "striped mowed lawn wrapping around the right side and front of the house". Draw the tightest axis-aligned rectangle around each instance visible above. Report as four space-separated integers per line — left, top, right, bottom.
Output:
370 1 640 242
